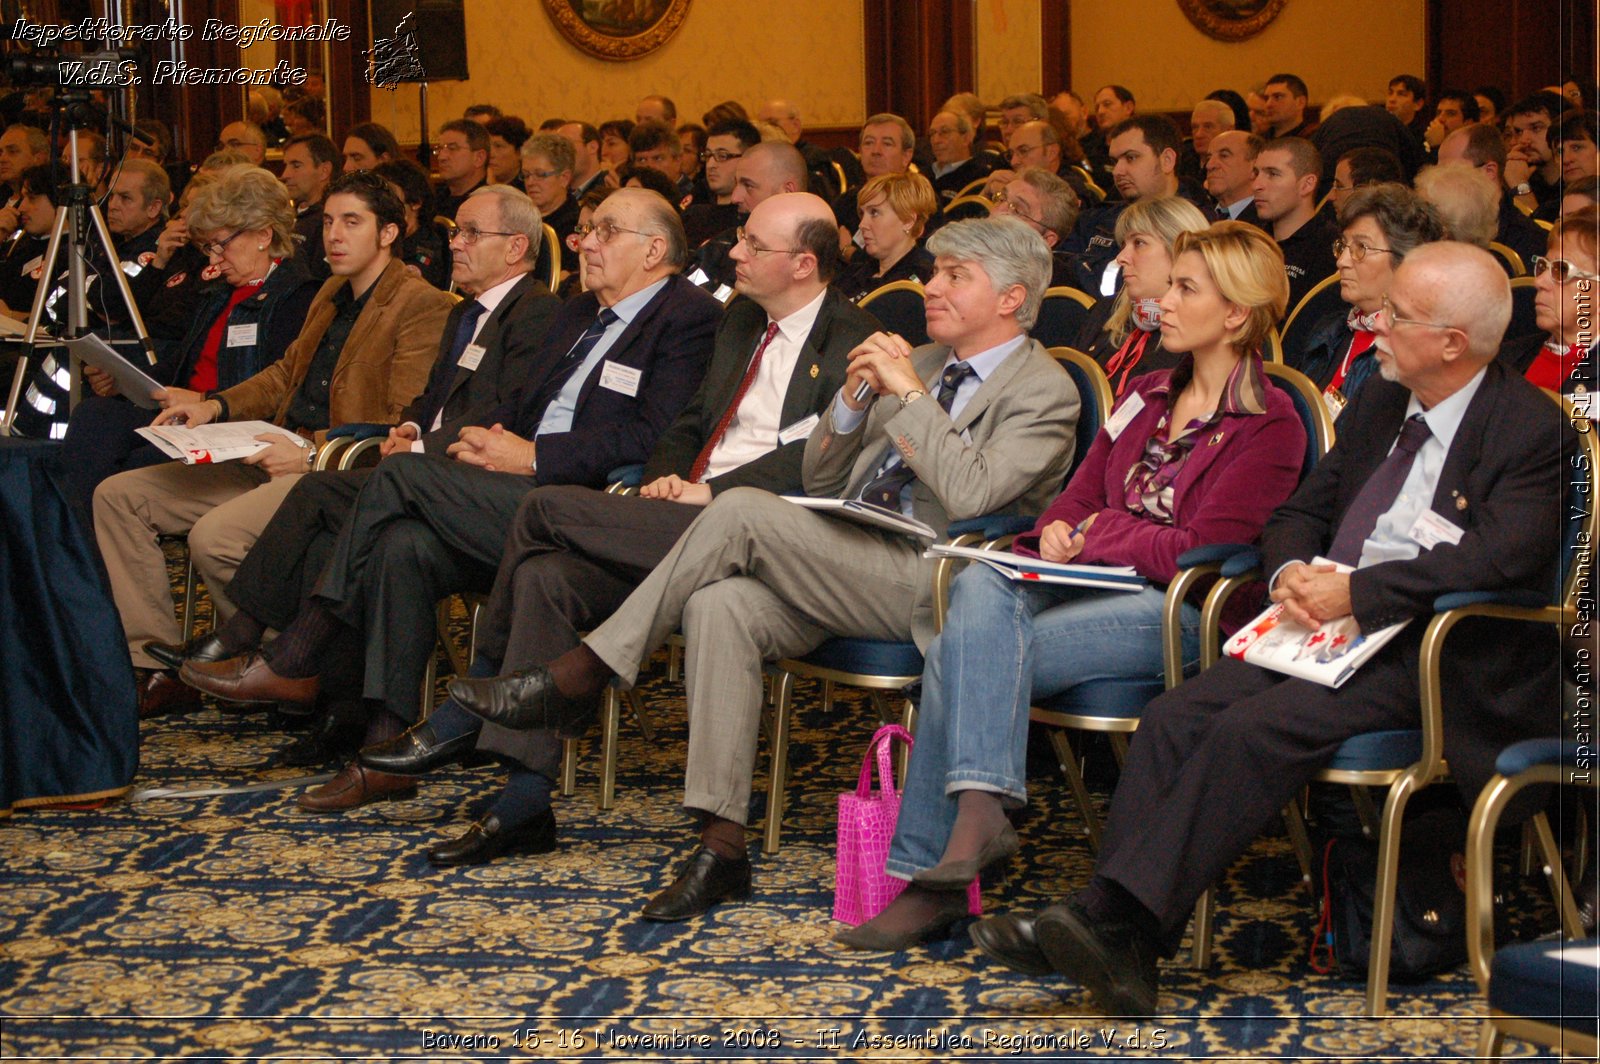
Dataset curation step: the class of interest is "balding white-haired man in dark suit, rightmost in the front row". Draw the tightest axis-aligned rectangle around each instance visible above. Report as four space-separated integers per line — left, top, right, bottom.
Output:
973 242 1576 1016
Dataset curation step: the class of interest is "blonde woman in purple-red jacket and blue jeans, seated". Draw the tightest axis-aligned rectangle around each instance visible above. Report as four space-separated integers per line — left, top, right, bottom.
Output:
835 222 1306 950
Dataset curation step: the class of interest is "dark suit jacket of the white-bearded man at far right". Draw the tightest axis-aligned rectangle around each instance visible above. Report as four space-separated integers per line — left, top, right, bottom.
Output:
1261 360 1576 797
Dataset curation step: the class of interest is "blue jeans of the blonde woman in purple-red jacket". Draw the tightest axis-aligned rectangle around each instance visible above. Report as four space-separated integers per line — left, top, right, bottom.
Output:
886 563 1200 880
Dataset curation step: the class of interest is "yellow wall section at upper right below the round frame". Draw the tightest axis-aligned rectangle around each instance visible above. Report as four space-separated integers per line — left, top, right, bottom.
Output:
1075 0 1426 110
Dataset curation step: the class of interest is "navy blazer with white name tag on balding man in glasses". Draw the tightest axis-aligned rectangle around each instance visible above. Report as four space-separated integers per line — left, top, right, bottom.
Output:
494 275 722 486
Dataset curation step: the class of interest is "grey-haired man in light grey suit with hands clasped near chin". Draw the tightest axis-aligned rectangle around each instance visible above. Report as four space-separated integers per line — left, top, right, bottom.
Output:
451 219 1078 920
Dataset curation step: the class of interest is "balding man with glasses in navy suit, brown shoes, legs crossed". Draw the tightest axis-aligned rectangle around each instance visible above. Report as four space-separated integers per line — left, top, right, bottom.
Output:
184 189 722 810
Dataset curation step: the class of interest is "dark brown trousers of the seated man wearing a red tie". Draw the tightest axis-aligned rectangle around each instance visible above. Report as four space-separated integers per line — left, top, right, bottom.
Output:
478 486 704 776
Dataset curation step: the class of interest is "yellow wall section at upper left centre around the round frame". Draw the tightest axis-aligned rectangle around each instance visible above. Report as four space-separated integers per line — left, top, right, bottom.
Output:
373 0 867 142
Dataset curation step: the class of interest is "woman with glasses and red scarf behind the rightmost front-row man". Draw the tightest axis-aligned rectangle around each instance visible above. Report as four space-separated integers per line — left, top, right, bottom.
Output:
1283 181 1445 418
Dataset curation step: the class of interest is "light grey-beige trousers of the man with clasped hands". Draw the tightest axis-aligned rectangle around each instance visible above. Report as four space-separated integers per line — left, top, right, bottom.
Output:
584 488 922 824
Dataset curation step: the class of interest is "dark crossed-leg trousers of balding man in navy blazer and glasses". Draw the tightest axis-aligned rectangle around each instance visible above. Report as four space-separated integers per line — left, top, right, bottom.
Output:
314 454 536 720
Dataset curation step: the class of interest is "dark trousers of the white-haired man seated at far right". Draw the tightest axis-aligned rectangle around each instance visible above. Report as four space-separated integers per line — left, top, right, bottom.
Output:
1096 632 1419 950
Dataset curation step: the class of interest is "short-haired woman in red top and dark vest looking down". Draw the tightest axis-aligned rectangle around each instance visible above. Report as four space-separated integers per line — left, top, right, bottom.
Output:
55 166 320 510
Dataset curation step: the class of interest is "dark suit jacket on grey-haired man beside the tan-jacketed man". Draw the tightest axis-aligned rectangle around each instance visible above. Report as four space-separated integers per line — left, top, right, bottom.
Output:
400 274 565 454
